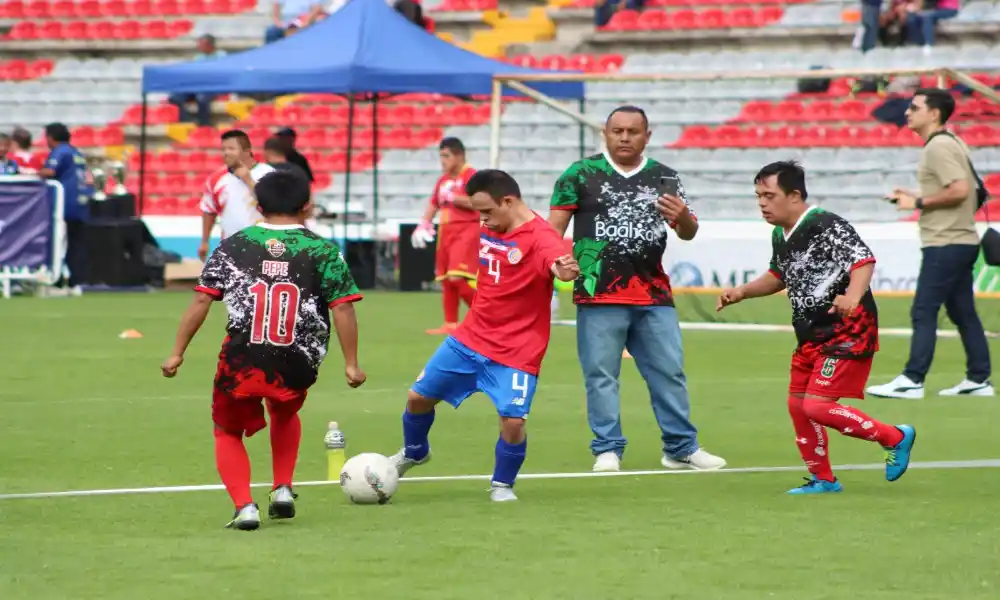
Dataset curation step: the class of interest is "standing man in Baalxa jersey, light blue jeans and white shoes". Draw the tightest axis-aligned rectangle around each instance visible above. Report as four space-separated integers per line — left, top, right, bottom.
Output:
549 106 726 471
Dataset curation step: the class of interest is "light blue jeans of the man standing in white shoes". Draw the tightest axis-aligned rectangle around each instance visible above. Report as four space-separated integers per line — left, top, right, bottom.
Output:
576 305 698 459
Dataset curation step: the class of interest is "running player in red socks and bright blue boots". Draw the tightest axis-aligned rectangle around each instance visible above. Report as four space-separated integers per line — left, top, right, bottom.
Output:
717 162 917 494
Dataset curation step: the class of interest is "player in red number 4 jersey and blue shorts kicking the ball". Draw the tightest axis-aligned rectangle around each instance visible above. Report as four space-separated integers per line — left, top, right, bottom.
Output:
392 169 580 502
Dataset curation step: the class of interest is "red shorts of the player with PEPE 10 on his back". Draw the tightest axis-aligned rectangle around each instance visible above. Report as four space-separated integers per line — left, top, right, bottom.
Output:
212 362 307 437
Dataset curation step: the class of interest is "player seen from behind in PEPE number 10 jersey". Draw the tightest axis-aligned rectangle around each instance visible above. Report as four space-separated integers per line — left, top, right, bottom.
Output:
161 172 365 530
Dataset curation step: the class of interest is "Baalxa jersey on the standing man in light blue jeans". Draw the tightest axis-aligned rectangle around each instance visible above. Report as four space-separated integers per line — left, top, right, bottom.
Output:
552 154 694 306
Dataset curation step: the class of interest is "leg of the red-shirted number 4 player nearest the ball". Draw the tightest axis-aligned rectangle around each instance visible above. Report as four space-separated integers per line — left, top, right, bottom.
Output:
391 337 478 476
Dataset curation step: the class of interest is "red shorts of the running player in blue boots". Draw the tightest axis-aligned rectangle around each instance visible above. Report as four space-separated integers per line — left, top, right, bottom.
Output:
788 350 872 399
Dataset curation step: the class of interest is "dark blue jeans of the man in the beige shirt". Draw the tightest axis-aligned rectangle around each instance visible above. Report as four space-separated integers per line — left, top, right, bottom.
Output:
903 244 990 383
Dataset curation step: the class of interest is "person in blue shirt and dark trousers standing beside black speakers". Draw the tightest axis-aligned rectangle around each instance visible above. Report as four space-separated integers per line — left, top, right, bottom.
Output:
39 123 93 288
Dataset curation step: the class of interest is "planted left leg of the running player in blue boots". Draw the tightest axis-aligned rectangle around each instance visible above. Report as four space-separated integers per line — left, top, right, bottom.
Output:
788 350 843 494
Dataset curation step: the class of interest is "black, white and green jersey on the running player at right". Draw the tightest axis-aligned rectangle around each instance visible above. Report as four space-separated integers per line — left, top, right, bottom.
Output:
770 206 878 358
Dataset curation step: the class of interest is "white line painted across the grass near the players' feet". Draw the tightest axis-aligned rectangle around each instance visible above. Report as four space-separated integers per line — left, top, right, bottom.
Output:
0 458 1000 500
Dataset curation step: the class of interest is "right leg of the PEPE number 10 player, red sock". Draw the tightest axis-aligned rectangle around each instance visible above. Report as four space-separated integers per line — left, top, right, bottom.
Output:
267 390 306 519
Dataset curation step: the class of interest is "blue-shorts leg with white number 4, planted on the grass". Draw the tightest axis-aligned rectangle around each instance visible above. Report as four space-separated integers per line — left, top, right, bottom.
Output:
477 360 538 502
